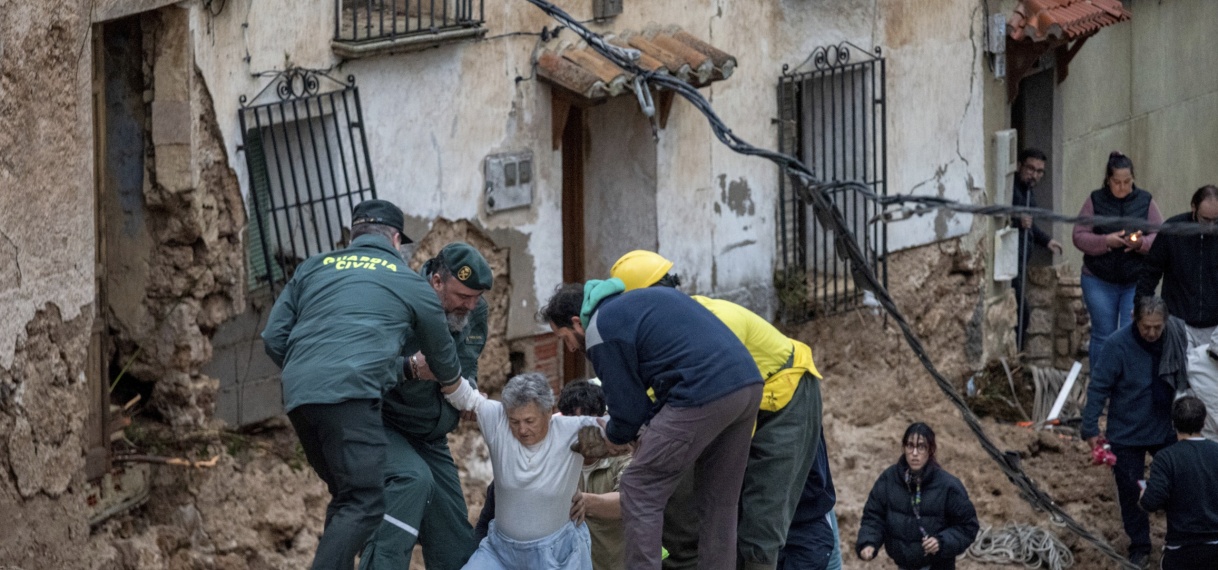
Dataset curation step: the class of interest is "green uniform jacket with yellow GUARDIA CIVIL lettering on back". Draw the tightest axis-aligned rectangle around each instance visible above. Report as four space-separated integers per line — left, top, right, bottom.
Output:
262 235 460 412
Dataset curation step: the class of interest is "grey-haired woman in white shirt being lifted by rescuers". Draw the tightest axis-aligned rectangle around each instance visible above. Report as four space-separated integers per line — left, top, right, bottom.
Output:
442 373 598 570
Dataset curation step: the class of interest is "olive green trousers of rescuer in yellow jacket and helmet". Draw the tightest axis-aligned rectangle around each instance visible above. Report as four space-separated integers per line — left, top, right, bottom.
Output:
663 374 821 570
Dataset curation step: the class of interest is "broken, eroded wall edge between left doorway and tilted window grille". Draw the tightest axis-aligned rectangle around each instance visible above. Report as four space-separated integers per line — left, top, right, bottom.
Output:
111 7 245 428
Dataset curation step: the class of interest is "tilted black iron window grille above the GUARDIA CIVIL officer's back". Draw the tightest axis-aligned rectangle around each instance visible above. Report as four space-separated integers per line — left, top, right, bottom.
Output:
238 68 376 296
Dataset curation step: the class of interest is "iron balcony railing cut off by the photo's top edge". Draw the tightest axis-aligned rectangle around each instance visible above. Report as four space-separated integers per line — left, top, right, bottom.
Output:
334 0 485 44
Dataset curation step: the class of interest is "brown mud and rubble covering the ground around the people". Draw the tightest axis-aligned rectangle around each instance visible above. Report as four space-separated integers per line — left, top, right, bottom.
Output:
64 245 1149 570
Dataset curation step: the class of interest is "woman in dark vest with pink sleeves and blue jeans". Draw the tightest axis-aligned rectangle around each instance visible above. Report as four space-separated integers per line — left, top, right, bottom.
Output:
1074 152 1163 367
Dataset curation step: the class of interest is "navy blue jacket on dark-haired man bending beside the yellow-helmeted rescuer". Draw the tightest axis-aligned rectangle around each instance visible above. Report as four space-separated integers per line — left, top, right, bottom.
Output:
585 287 762 445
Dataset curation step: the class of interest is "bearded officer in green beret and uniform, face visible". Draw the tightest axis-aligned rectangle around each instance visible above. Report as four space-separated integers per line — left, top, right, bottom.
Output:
359 242 493 570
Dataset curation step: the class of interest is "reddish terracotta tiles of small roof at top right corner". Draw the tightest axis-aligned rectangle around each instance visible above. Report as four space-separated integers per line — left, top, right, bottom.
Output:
1006 0 1133 41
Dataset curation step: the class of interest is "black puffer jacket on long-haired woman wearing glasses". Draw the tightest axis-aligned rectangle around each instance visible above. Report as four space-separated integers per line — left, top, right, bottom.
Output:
855 457 980 570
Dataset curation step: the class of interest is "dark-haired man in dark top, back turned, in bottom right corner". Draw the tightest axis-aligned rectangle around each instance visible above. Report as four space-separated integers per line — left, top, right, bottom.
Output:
1138 396 1218 570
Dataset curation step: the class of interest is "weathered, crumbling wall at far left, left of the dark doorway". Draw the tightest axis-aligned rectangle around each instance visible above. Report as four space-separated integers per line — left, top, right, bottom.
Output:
0 0 107 569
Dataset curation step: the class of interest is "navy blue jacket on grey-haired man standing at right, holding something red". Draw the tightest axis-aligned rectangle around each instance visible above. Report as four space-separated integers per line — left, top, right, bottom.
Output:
1079 325 1175 446
